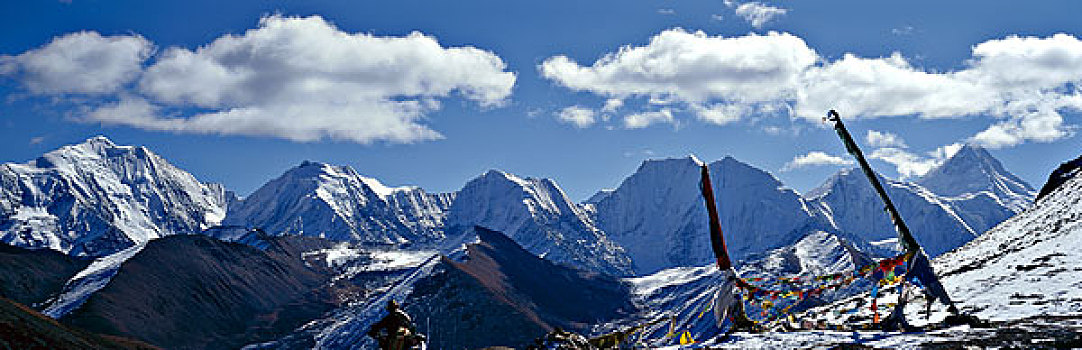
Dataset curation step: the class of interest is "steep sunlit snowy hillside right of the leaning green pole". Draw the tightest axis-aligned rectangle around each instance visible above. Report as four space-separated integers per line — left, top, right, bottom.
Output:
935 163 1082 320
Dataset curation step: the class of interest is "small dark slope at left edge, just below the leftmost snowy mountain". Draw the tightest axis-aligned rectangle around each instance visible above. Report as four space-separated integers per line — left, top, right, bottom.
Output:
0 244 90 306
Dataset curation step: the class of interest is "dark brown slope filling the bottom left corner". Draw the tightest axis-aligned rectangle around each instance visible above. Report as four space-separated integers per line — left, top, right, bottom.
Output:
0 298 155 349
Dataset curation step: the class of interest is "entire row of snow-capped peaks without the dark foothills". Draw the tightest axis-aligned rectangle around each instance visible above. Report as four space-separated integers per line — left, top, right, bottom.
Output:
0 137 1035 275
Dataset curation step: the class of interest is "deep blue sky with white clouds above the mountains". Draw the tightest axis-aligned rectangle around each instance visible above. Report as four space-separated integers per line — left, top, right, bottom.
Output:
0 0 1082 199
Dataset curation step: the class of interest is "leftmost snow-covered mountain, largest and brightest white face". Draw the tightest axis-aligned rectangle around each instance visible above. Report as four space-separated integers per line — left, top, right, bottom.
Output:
0 137 228 256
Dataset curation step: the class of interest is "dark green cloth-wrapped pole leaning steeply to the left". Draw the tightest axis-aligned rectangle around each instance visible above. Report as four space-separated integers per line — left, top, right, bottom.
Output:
824 109 958 326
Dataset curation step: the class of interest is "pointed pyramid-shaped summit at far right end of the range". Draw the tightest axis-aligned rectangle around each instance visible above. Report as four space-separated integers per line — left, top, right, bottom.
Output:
916 144 1037 212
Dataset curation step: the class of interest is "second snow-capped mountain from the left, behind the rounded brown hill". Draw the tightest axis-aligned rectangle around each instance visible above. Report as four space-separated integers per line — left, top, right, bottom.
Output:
224 161 453 243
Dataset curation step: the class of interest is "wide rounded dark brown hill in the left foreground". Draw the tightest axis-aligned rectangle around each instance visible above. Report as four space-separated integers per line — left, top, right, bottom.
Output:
64 235 332 349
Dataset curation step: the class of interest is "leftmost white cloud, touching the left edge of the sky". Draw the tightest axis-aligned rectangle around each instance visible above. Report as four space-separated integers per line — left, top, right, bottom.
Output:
0 31 154 94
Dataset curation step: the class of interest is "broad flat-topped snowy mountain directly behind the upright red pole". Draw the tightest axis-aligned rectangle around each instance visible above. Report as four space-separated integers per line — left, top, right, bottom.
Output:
595 156 814 274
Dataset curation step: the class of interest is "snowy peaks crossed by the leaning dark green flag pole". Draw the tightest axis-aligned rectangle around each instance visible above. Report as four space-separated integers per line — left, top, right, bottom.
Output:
807 145 1034 256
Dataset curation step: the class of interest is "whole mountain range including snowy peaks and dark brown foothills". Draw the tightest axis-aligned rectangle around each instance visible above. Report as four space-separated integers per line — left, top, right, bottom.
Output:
0 137 1051 348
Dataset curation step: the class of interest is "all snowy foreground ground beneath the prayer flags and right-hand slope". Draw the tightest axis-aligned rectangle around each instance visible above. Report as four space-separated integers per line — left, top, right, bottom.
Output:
643 166 1082 349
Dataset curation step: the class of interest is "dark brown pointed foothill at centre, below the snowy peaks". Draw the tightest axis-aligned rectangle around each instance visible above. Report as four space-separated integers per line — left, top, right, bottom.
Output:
406 228 634 349
